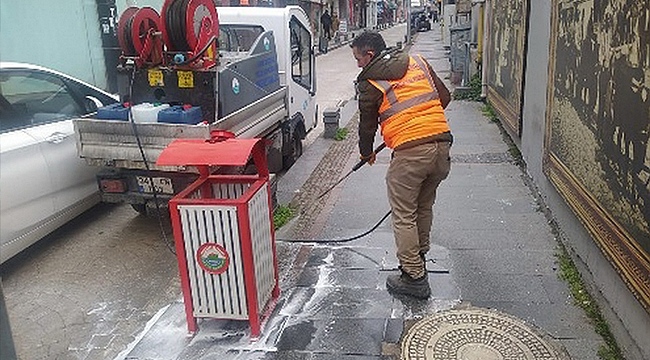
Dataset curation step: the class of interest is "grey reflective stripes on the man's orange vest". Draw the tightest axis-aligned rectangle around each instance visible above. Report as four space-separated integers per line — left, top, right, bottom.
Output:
373 56 439 122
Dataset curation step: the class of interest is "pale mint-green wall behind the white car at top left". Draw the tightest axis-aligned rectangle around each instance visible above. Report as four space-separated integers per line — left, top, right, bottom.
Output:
0 0 163 89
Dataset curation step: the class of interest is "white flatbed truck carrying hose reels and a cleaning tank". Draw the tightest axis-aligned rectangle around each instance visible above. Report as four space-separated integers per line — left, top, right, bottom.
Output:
73 1 318 213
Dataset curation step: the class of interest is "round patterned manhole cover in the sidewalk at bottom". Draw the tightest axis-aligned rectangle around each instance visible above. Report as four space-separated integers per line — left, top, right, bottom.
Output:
402 308 567 360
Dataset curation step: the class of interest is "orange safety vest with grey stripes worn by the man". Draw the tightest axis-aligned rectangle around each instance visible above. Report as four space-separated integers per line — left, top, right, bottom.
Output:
368 56 450 149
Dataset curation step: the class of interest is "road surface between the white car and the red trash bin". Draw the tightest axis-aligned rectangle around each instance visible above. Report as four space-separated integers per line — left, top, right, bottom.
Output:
0 204 180 360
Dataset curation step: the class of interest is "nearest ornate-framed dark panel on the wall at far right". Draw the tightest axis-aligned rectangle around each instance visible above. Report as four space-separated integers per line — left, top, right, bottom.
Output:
544 0 650 311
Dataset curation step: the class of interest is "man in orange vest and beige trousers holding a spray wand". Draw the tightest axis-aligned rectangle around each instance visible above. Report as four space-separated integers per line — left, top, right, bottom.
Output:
351 32 453 299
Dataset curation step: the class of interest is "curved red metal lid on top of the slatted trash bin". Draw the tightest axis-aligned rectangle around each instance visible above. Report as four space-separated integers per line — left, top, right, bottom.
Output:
156 139 264 166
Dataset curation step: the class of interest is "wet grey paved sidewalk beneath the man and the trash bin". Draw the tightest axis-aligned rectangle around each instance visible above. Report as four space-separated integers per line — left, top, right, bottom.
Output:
117 23 602 360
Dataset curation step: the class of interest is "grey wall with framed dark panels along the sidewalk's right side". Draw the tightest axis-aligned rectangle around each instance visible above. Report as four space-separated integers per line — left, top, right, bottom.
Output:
443 0 650 360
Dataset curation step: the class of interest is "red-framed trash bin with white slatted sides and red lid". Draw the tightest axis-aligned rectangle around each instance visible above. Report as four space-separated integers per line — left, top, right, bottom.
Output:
156 135 280 338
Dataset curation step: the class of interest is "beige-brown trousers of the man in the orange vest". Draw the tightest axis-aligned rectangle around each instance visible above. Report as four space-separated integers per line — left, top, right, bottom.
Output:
386 142 451 279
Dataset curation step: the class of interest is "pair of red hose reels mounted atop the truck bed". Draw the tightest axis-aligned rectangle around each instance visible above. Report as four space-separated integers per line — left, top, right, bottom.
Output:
118 0 219 68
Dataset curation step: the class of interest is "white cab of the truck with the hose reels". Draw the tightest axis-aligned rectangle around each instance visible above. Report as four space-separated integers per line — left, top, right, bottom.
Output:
218 6 318 167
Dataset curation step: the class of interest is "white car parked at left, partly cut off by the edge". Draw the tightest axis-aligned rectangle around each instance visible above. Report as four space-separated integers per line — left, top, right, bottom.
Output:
0 62 118 263
